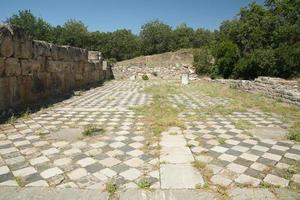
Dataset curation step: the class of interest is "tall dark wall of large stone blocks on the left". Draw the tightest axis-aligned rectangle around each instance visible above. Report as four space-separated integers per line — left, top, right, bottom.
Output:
0 25 111 111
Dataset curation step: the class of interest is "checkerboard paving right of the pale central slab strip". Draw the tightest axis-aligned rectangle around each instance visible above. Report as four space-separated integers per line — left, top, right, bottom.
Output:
174 98 300 187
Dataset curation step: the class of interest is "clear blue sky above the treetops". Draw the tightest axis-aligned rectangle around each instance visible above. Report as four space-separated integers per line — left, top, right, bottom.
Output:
0 0 263 33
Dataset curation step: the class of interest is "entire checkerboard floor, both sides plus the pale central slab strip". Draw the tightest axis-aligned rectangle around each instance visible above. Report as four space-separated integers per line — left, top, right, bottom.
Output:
0 81 300 195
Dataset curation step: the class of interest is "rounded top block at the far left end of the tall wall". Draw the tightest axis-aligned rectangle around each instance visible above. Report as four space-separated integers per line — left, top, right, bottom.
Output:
0 25 14 57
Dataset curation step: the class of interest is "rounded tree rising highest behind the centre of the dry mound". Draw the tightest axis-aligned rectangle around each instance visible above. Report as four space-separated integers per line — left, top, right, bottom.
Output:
140 20 174 55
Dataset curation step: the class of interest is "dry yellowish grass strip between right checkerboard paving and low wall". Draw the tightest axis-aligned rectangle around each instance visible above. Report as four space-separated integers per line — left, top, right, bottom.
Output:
180 81 300 141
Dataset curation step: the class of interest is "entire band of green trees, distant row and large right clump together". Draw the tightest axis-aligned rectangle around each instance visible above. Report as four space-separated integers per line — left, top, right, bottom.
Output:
7 0 300 79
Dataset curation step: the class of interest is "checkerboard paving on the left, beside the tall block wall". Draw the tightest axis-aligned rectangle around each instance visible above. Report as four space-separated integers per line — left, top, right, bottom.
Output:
0 81 160 189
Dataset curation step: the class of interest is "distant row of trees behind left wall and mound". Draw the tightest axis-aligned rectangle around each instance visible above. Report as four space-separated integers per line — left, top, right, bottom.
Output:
6 10 214 61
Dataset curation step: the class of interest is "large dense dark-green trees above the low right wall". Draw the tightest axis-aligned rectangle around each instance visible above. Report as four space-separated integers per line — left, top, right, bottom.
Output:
214 0 300 79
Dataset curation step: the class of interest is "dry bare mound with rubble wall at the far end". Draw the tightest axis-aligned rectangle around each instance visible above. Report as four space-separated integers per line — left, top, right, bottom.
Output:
113 49 194 79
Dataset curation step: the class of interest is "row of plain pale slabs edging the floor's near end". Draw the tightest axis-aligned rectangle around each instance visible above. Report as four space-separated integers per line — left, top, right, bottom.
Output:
0 186 299 200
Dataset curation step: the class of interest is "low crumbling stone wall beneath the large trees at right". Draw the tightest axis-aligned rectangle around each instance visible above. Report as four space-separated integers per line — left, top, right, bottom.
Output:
214 76 300 106
